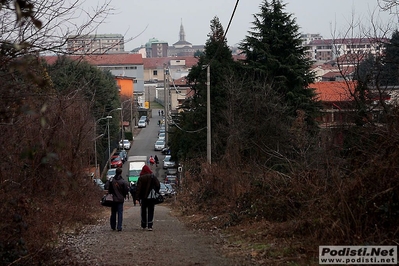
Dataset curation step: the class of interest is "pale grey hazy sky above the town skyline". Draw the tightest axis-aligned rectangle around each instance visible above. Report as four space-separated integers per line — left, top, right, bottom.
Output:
81 0 398 50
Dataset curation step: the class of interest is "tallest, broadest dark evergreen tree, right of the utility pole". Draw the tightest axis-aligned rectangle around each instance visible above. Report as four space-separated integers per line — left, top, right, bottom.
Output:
240 0 319 124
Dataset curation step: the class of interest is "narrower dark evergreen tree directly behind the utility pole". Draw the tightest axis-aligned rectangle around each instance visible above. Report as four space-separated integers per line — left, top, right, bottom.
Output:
171 17 234 160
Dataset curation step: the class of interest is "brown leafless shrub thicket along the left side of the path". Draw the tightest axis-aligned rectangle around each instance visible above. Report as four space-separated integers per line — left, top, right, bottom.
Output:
0 90 101 265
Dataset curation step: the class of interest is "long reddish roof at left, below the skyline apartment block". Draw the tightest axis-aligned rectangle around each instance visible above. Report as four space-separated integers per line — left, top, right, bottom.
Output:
43 53 143 66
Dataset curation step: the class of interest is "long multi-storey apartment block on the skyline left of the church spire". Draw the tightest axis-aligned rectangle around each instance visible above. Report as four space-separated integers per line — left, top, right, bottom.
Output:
67 34 125 55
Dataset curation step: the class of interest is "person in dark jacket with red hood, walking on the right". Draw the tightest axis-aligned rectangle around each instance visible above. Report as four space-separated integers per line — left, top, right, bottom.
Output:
136 165 161 231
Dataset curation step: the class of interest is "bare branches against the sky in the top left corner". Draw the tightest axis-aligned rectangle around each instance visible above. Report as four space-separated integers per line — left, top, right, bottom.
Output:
0 0 112 56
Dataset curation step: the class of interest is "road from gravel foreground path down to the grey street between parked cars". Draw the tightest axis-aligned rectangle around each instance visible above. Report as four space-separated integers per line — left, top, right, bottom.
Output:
65 110 245 266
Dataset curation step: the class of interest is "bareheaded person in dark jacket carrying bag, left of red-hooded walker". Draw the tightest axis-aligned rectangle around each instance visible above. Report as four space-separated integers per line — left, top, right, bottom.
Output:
104 168 129 231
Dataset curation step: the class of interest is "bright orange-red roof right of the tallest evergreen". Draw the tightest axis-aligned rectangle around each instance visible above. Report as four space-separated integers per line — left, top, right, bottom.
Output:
308 81 356 102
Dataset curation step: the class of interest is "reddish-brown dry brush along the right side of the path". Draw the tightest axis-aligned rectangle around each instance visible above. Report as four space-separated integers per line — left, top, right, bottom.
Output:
179 123 399 247
